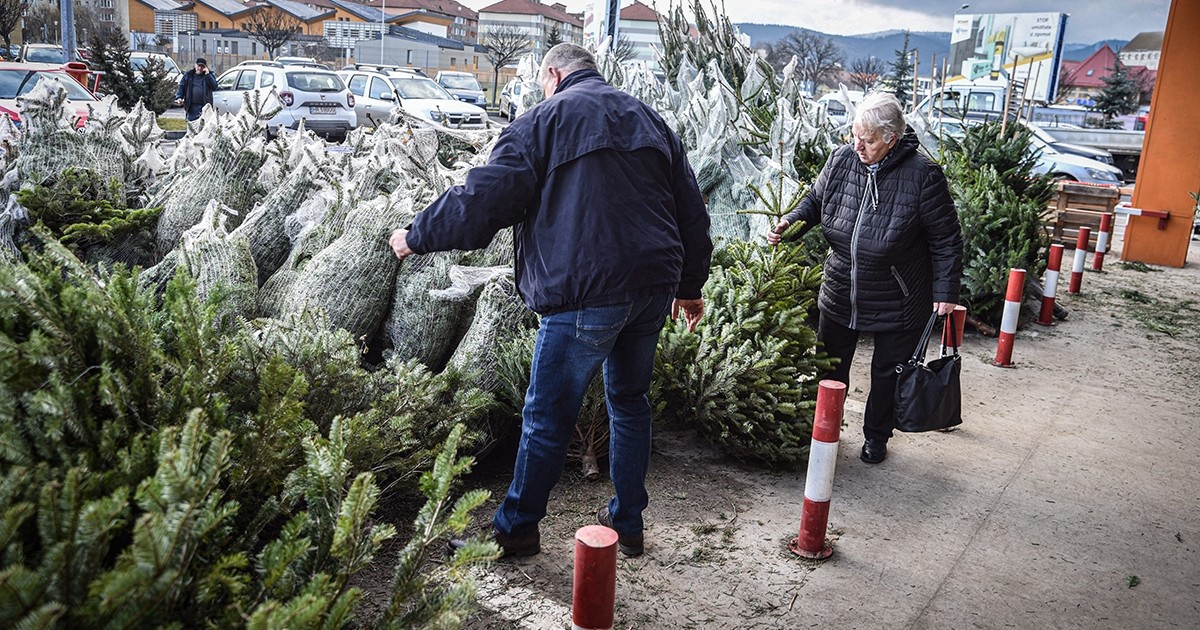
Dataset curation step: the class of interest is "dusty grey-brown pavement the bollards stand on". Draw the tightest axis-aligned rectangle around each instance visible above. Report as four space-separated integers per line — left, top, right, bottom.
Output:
451 241 1200 629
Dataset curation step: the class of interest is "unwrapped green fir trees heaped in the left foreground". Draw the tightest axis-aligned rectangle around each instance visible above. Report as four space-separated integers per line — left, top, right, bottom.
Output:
0 236 498 628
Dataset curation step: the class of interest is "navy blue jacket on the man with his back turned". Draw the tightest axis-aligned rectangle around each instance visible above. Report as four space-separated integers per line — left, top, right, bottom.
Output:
408 70 713 314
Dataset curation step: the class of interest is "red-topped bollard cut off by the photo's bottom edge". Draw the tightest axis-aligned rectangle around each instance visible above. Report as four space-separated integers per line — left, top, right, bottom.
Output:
571 526 617 630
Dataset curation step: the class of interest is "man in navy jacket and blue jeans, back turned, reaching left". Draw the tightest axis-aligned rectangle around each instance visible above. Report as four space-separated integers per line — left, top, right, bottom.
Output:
391 43 713 556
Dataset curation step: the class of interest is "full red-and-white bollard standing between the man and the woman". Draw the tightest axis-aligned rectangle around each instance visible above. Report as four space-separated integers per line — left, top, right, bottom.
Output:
787 379 846 560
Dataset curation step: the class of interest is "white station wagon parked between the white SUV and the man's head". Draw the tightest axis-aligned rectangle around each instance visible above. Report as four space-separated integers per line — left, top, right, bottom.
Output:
340 70 487 130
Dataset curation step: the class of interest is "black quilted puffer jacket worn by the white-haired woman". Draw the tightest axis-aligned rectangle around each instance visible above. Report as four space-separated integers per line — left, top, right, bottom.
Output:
784 130 962 332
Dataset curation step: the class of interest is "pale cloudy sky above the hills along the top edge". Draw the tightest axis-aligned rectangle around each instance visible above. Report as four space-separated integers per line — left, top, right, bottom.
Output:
460 0 1171 43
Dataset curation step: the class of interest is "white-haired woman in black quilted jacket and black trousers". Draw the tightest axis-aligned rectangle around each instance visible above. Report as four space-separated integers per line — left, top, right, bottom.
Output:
767 92 962 463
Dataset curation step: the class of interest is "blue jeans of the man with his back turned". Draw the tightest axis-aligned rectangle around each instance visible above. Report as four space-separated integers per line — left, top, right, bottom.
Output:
493 294 673 536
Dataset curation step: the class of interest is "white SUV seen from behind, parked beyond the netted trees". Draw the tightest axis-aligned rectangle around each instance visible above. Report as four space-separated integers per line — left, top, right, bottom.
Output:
212 61 358 139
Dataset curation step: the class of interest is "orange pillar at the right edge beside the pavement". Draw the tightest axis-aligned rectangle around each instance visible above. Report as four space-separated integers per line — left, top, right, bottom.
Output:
1121 0 1200 266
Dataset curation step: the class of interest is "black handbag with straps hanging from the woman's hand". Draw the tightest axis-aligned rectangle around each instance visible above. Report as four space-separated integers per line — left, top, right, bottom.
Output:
895 311 962 433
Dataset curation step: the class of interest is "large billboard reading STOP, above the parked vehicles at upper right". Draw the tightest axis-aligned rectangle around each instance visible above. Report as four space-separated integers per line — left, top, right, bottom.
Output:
947 13 1067 102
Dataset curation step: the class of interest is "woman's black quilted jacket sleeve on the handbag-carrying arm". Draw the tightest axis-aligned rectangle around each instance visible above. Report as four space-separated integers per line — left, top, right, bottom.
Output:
918 166 962 304
